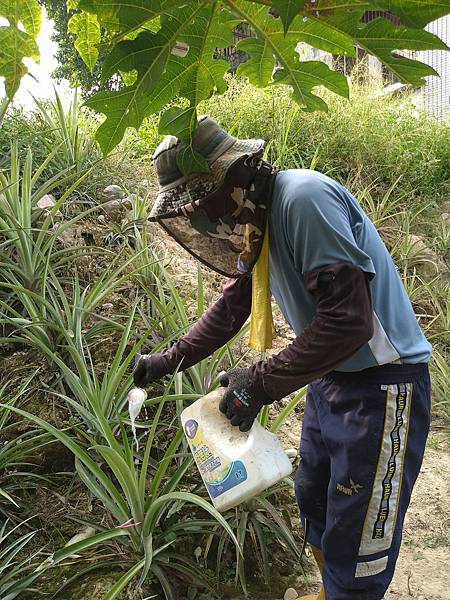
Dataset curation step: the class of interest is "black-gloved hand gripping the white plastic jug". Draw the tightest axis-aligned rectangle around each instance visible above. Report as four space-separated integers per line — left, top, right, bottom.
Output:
219 369 273 431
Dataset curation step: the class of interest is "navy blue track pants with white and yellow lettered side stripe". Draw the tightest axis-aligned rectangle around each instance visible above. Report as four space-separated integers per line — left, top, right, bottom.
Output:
296 364 430 600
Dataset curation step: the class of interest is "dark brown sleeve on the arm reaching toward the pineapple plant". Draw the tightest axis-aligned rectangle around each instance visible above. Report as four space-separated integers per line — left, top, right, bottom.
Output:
154 275 252 375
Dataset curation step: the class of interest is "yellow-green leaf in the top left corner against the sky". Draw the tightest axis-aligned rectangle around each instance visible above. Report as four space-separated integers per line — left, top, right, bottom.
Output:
0 0 42 99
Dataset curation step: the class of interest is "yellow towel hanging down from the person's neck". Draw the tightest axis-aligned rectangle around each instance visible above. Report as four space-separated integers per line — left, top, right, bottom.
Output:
248 224 276 352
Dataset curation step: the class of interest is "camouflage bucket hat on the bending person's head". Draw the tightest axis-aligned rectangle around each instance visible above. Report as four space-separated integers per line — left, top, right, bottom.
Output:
149 116 266 221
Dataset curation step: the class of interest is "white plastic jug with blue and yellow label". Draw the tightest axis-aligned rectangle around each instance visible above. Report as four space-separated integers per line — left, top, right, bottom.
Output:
181 388 292 511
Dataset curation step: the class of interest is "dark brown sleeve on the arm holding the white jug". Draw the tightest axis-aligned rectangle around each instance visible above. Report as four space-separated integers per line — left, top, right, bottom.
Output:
250 263 373 400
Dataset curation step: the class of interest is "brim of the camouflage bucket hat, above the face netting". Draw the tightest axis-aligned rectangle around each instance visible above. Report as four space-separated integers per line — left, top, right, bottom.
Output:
149 139 266 221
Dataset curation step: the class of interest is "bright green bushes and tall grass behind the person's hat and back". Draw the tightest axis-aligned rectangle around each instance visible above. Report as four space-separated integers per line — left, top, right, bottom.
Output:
197 77 450 206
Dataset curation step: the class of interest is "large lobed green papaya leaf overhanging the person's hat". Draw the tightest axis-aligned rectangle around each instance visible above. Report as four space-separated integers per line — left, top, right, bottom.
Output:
77 0 450 164
